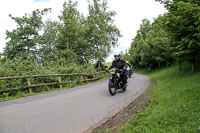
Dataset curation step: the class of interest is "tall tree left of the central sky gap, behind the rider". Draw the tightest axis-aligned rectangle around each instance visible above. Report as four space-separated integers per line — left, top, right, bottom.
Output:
86 0 121 62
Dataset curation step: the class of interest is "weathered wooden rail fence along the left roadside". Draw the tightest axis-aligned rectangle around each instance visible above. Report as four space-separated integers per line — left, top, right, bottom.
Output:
0 71 106 93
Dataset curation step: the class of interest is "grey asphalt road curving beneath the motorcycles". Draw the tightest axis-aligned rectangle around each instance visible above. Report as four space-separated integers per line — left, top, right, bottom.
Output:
0 74 150 133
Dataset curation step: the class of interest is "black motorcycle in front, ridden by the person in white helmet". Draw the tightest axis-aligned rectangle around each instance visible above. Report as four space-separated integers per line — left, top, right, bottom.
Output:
108 68 127 96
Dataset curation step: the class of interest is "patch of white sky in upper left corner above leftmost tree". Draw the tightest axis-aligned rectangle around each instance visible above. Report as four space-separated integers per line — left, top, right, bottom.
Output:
0 0 64 52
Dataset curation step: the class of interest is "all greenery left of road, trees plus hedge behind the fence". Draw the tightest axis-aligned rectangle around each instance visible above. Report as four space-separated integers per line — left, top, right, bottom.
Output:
0 0 121 97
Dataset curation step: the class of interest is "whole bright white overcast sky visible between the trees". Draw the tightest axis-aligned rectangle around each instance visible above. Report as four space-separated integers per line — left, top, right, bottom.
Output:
0 0 166 61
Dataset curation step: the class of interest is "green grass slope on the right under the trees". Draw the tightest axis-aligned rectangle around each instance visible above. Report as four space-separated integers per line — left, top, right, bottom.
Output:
120 64 200 133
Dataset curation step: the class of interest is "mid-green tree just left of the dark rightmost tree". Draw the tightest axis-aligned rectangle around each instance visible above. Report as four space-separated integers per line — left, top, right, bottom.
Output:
146 15 173 67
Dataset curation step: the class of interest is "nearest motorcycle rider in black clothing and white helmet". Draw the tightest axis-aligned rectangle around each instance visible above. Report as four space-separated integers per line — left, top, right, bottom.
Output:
106 53 127 85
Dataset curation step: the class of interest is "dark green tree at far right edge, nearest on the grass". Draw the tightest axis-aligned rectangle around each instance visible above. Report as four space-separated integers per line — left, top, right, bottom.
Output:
156 0 200 71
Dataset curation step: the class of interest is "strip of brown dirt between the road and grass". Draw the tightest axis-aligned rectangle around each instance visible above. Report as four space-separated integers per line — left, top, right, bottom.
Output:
91 79 157 133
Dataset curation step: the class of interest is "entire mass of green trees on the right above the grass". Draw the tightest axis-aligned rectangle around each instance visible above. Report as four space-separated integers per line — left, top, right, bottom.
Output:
128 0 200 71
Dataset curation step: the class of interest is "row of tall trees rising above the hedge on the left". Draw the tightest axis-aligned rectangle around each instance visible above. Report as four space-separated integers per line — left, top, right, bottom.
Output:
3 0 121 66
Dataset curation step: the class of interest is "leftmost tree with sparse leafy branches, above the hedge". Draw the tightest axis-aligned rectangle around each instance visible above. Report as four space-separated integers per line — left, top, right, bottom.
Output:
4 9 50 60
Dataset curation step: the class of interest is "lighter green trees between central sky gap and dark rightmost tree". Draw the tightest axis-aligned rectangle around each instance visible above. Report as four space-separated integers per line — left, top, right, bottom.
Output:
129 16 172 69
